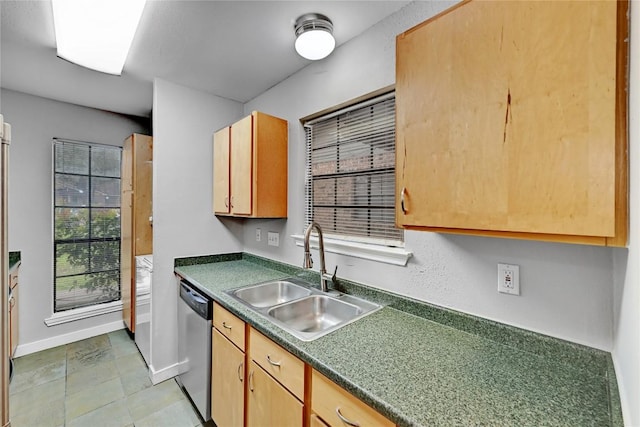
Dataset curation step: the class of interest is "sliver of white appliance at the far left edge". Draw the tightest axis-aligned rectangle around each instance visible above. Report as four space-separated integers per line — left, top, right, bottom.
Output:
0 114 11 427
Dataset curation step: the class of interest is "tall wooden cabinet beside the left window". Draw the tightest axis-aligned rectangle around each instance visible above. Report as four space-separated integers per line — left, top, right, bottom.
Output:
120 134 153 332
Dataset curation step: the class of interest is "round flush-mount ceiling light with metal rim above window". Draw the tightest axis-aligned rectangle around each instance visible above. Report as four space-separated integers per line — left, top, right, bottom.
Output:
295 13 336 61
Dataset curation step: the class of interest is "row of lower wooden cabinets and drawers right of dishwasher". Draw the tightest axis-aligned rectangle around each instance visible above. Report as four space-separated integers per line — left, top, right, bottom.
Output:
211 303 395 427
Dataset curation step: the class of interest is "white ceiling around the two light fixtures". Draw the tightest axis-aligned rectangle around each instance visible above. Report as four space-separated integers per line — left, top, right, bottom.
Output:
0 0 409 116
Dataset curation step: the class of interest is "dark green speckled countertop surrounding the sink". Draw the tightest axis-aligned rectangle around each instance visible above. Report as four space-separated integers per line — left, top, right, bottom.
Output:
175 254 623 427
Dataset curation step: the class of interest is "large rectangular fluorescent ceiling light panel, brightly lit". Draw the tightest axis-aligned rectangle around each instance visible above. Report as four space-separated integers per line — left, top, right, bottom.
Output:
51 0 145 75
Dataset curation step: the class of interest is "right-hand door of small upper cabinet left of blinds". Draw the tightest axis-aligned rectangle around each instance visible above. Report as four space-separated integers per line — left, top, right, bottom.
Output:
231 116 253 215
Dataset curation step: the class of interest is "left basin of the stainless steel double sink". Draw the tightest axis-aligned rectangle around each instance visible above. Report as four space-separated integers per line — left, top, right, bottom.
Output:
232 280 311 308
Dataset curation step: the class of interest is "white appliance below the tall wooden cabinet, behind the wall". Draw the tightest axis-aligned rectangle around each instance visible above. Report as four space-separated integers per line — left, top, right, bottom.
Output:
135 255 153 366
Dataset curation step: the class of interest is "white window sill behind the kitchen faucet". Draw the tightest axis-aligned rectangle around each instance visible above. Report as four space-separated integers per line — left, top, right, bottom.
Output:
291 234 413 267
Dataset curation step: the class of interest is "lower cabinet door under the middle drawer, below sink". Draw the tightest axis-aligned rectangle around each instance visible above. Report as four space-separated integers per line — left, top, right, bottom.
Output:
247 361 303 427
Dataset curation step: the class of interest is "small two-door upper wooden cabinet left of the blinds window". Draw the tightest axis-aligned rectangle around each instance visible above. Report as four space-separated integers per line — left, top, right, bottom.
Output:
213 111 288 218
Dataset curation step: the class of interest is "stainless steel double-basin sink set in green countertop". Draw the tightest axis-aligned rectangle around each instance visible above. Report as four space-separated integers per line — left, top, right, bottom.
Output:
227 278 382 341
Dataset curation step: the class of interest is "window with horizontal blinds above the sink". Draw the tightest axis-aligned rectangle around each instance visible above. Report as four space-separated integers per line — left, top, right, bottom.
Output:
305 93 403 246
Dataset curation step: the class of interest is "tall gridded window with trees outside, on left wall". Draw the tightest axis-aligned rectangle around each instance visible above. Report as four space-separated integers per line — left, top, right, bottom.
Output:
53 139 122 312
